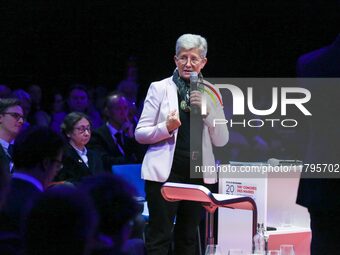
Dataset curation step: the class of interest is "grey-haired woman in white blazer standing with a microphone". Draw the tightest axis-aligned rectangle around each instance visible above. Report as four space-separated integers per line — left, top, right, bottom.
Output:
135 34 228 255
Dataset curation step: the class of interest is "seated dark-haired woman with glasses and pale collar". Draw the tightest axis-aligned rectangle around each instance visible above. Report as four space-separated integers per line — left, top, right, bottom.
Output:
57 112 103 184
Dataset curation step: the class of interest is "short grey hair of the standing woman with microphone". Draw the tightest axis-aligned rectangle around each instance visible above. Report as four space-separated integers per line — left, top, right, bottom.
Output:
176 34 208 58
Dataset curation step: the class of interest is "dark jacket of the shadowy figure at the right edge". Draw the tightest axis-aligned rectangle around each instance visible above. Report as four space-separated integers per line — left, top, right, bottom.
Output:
296 36 340 212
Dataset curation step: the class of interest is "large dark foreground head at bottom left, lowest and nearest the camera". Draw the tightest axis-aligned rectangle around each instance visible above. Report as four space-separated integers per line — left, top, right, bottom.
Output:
23 186 97 255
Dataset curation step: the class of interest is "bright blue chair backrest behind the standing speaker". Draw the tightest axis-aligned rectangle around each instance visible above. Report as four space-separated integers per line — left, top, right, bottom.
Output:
112 164 145 198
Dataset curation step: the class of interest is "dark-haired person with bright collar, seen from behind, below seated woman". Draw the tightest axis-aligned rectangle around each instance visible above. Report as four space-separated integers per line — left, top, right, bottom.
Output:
0 127 64 232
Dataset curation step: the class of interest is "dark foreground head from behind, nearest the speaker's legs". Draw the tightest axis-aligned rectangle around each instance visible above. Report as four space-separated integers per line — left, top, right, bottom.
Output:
80 175 144 255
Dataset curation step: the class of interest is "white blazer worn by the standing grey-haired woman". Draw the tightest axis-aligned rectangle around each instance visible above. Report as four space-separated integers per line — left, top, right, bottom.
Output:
135 77 229 183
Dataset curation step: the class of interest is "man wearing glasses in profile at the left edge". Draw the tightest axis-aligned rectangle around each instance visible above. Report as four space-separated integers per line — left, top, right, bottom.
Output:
0 98 24 171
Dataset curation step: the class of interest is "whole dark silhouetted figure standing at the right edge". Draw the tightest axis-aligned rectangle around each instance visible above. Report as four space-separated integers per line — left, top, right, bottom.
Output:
297 36 340 255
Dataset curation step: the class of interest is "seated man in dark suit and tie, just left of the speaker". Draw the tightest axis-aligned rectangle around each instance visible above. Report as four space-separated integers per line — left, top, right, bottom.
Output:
89 93 143 172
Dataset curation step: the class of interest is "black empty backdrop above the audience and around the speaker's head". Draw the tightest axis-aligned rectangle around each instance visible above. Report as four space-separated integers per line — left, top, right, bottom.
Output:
0 0 340 93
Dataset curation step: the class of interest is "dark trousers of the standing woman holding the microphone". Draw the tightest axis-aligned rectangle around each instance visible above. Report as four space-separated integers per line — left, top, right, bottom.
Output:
145 174 203 255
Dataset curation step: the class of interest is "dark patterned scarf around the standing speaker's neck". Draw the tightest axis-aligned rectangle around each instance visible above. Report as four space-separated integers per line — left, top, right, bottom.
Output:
172 68 203 112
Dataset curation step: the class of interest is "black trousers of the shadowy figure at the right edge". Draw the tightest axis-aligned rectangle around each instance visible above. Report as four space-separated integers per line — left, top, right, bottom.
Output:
309 211 340 255
